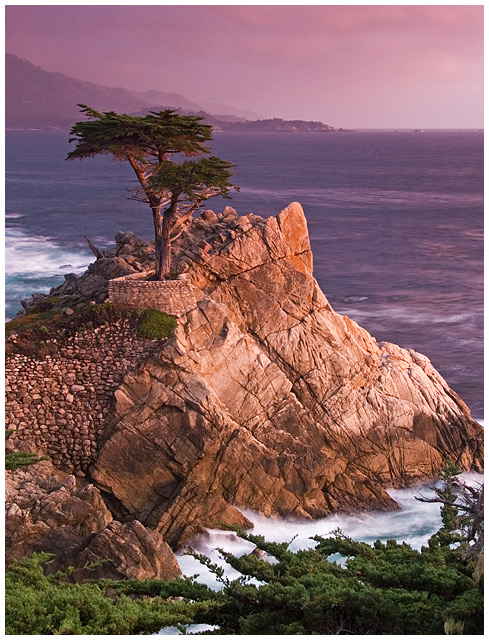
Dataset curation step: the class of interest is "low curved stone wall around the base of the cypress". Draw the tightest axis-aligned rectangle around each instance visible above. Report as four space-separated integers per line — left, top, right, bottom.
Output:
109 273 202 317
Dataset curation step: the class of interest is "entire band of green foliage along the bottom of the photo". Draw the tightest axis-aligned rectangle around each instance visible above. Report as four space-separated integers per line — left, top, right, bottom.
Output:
6 468 484 635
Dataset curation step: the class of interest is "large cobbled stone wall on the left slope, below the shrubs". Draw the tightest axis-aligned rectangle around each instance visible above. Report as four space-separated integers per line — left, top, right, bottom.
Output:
5 320 158 475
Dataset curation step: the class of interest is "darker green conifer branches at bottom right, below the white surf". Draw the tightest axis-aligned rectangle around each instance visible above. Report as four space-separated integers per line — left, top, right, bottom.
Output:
186 532 483 635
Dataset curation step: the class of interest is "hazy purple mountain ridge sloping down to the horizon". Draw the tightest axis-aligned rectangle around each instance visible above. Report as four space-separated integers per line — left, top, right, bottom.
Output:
5 53 334 131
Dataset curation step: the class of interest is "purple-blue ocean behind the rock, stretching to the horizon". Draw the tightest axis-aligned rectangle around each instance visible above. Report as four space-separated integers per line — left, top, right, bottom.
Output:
6 131 483 419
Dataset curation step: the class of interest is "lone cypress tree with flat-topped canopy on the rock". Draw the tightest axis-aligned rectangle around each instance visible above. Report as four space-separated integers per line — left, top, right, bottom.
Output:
67 104 237 280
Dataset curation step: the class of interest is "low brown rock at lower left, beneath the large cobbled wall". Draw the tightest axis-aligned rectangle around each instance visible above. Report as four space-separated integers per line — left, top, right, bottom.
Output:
5 461 181 582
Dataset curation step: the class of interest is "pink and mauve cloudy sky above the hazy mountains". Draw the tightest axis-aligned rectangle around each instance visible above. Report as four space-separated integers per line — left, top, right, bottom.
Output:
6 5 483 128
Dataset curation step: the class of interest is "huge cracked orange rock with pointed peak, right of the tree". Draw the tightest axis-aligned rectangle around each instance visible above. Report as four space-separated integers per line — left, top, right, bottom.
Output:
91 203 482 546
